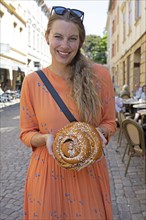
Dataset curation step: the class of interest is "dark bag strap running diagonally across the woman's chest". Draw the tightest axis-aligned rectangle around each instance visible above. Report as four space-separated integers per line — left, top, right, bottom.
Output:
36 70 77 122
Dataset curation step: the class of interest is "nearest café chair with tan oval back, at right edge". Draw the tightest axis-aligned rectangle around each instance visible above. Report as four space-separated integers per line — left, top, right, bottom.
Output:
122 119 146 183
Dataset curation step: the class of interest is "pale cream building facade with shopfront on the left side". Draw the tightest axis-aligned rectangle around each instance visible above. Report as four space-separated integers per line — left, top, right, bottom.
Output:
0 0 50 91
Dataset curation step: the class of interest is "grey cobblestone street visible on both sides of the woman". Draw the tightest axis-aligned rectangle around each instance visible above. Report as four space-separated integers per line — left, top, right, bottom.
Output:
0 103 146 220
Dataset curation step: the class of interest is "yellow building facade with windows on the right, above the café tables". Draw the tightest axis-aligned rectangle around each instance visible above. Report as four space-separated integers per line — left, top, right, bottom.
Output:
106 0 146 94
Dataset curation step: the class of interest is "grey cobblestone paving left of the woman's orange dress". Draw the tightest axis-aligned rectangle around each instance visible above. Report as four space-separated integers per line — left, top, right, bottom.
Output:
0 104 31 220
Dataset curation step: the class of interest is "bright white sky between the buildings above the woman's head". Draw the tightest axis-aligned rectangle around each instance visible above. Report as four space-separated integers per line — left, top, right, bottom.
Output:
45 0 109 37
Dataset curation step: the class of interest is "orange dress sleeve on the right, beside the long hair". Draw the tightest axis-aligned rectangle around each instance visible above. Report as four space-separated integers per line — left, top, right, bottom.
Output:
94 65 116 137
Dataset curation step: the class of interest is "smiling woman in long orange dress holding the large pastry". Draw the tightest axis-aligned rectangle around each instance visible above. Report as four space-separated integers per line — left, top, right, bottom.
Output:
20 7 116 220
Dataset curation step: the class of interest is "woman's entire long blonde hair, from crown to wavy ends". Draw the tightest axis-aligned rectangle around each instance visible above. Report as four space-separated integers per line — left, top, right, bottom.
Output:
46 11 101 124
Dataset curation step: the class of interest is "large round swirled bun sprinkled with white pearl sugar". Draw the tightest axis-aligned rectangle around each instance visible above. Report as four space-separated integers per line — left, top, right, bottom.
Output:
53 122 102 171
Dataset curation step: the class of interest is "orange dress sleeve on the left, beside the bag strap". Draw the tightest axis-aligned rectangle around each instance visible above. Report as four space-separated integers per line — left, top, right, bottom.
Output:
20 75 39 147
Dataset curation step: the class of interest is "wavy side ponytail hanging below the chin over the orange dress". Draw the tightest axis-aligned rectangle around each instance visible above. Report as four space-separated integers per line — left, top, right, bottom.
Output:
70 51 101 123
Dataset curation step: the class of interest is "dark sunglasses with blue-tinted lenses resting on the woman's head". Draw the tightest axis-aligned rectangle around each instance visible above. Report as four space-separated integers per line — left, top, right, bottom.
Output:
50 6 84 21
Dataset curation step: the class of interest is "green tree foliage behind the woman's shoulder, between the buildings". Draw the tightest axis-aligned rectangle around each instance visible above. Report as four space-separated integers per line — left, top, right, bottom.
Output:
83 34 107 64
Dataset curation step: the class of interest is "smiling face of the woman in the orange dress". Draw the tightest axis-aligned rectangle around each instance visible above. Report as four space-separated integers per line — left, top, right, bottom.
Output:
46 20 80 66
